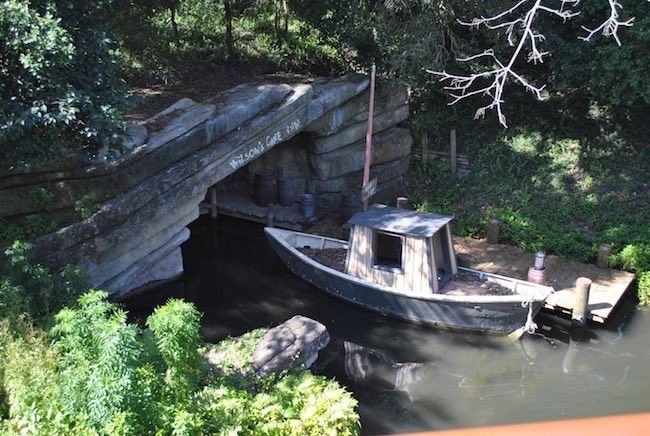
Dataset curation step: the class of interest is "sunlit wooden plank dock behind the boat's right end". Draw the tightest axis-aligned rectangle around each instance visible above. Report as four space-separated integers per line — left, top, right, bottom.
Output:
454 236 634 323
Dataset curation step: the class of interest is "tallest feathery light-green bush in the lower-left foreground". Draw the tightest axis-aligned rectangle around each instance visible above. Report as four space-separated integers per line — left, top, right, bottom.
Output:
50 291 142 431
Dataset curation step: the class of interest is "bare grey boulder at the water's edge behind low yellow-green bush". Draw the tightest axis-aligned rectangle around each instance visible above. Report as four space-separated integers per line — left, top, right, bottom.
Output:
252 315 330 375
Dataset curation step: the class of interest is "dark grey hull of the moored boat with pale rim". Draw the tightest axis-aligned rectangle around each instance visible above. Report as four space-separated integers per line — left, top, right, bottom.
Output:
267 230 544 335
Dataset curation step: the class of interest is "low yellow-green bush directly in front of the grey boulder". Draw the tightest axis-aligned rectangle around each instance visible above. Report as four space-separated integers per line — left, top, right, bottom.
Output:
201 329 359 435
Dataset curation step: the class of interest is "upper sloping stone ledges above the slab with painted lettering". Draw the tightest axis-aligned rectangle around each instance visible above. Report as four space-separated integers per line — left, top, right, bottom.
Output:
0 85 291 217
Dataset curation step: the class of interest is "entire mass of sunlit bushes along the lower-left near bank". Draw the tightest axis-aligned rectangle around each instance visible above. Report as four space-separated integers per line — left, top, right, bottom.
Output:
0 291 359 435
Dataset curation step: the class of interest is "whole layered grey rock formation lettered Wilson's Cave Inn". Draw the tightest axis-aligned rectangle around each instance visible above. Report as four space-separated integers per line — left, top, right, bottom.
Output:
0 75 412 294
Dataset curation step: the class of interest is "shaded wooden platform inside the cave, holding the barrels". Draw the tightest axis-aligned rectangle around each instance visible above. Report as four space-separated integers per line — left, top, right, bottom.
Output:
200 192 316 231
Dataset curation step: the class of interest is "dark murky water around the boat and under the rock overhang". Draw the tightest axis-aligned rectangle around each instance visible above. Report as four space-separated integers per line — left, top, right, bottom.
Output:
126 218 650 434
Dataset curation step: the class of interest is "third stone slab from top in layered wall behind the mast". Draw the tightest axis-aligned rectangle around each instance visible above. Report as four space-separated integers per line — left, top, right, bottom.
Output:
309 127 413 180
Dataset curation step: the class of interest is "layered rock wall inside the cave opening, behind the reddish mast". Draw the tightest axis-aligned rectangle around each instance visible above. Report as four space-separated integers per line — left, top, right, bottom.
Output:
247 83 413 208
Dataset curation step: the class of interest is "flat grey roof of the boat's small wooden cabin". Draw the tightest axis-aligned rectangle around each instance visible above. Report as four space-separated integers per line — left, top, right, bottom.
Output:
348 206 454 238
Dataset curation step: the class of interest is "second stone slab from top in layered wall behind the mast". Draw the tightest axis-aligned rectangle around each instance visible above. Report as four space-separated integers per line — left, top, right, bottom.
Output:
310 105 409 154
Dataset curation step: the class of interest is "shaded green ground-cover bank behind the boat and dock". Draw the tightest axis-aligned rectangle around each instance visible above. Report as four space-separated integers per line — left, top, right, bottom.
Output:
408 108 650 301
